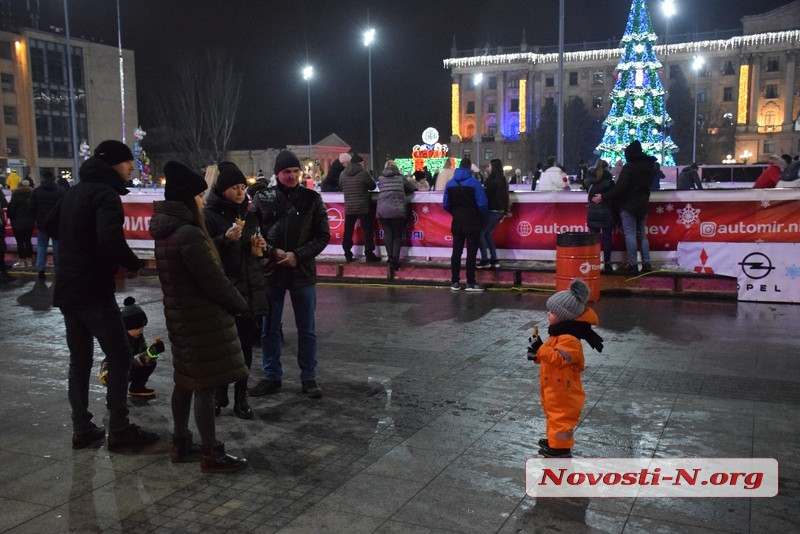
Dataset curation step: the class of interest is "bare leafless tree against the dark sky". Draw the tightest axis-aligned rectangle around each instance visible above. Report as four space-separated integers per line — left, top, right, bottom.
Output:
148 49 242 169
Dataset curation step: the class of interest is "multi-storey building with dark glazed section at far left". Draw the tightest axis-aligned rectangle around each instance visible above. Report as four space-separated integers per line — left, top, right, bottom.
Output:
0 29 139 183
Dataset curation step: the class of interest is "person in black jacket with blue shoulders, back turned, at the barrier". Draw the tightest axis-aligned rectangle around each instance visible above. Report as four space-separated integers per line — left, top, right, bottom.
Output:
442 158 489 292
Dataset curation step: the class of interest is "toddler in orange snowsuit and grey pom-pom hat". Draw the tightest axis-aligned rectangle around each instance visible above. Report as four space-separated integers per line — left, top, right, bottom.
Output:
528 278 603 458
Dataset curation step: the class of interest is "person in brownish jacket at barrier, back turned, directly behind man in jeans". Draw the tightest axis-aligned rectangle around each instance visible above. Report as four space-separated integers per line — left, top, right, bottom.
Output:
339 154 380 262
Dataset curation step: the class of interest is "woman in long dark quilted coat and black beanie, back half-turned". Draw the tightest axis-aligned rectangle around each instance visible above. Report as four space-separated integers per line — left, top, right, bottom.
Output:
150 161 248 473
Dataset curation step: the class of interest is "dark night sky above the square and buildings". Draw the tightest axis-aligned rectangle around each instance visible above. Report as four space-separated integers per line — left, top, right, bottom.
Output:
13 0 791 160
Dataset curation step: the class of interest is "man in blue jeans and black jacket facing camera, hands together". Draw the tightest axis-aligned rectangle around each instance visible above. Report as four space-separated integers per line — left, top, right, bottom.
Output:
250 150 331 399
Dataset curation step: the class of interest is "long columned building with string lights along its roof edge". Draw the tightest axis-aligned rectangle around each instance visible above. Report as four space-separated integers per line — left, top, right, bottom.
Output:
444 0 800 172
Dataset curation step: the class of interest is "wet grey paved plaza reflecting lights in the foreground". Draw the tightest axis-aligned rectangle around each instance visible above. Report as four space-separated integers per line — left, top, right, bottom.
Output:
0 273 800 534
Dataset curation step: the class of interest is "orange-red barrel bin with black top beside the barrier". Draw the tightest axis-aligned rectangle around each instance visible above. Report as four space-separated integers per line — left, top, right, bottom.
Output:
556 232 602 302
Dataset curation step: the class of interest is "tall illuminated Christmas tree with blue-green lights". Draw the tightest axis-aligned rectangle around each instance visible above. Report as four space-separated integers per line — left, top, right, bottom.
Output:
597 0 678 166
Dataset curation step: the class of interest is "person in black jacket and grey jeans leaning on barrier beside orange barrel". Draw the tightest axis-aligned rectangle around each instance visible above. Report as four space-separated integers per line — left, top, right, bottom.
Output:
592 140 656 274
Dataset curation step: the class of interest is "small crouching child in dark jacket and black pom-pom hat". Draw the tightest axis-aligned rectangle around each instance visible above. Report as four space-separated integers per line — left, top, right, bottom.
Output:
100 297 164 397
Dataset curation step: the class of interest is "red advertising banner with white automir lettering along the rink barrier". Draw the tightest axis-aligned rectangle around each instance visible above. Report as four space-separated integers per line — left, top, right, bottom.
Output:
6 189 800 261
